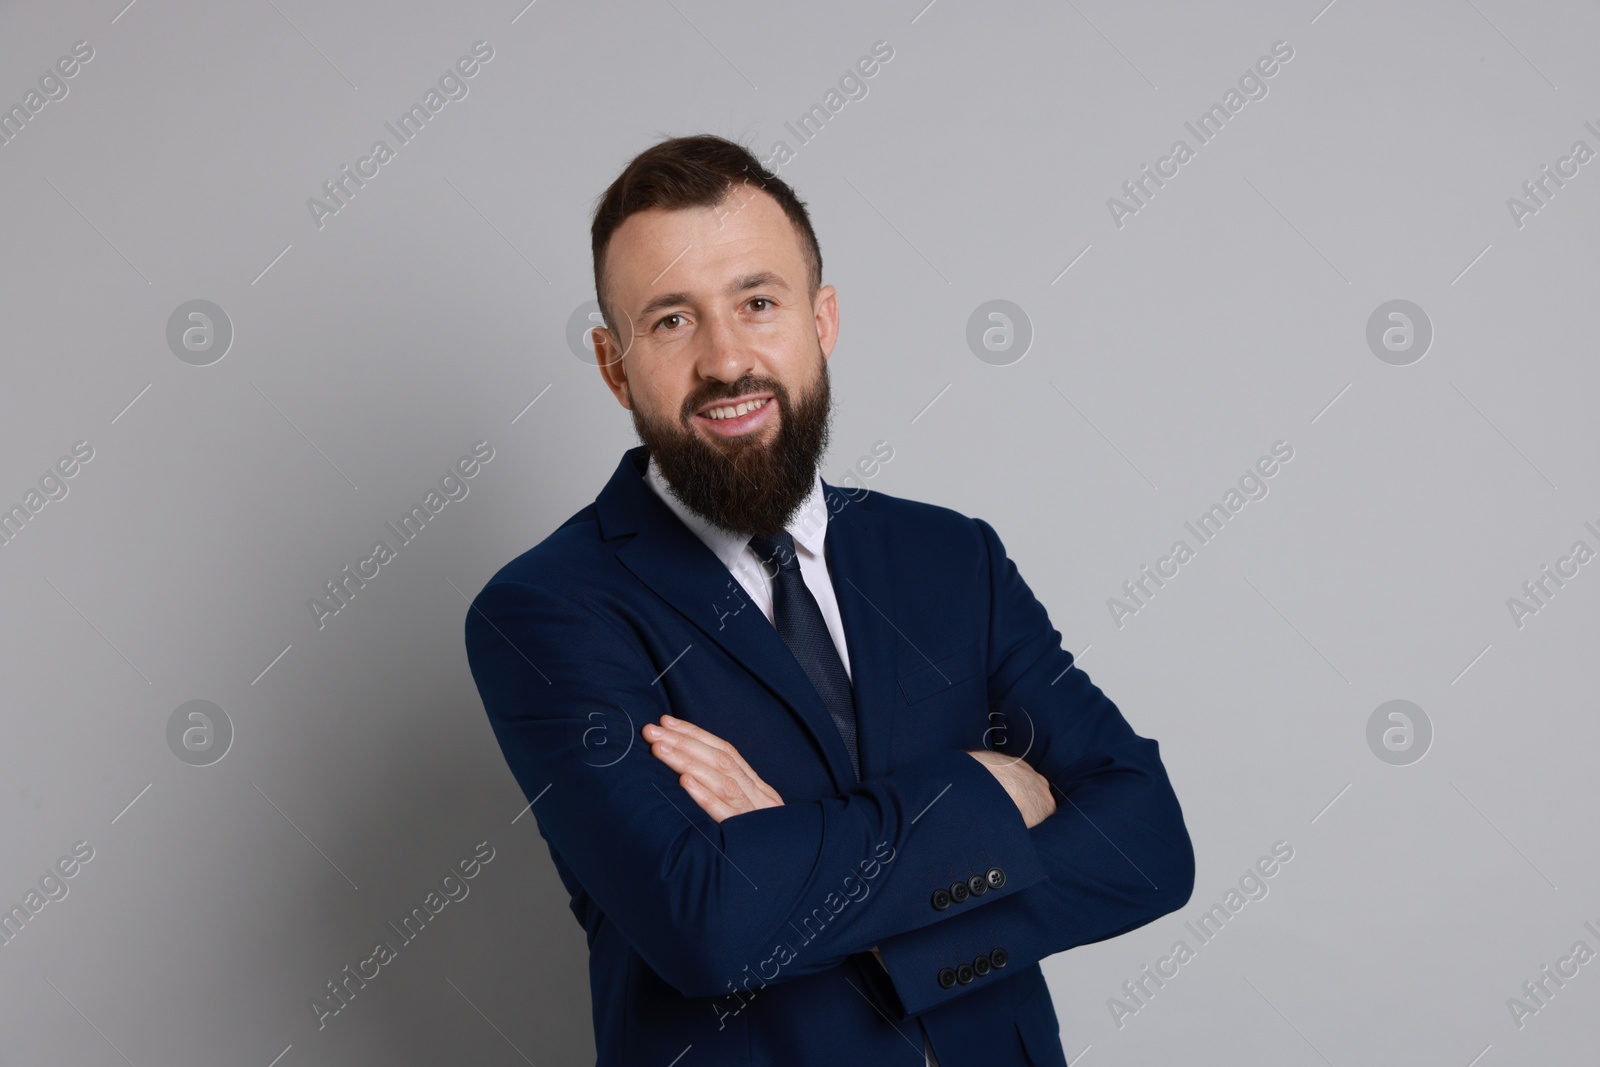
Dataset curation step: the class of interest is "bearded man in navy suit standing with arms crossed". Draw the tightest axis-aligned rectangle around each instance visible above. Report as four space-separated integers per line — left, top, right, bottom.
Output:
466 136 1194 1067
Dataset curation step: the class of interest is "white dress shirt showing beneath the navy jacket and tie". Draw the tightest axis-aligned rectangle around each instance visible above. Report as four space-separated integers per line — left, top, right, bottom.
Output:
645 458 939 1067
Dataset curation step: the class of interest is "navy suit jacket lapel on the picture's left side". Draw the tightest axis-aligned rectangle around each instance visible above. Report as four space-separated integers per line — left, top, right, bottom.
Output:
595 446 864 790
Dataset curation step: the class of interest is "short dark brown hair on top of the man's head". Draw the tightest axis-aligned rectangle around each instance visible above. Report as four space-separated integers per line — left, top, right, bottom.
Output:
589 133 822 331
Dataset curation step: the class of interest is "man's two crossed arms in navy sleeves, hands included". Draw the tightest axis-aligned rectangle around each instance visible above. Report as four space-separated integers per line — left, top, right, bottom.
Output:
466 522 1194 1014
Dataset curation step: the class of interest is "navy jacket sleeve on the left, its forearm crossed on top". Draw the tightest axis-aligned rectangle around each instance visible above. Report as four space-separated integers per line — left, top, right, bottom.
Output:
466 579 1045 997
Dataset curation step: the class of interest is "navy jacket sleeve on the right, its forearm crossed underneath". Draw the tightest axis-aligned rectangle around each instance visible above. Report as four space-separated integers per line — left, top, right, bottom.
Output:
880 520 1195 1014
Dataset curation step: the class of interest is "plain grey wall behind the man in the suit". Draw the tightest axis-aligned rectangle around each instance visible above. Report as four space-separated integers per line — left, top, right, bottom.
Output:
0 0 1600 1067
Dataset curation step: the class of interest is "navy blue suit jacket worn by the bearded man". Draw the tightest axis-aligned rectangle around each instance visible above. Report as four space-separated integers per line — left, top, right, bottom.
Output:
466 446 1194 1067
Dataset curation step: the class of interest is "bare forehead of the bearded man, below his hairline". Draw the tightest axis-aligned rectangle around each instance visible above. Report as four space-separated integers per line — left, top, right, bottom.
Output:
605 186 806 306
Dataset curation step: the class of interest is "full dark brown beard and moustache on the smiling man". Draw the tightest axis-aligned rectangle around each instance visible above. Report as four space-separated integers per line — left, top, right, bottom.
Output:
634 361 832 536
